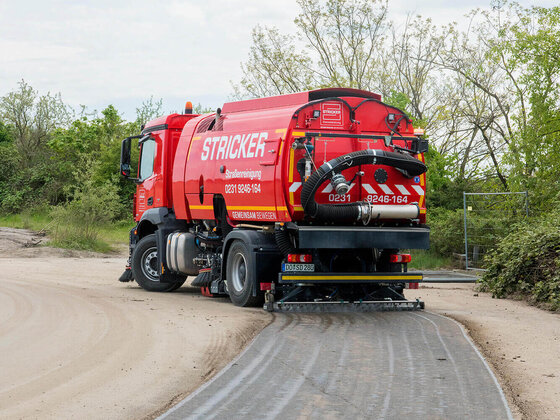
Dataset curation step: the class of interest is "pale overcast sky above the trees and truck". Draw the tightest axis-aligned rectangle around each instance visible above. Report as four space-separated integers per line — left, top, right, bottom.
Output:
0 0 558 120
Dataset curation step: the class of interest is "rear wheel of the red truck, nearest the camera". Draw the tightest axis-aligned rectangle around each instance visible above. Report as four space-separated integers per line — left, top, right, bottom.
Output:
226 240 263 307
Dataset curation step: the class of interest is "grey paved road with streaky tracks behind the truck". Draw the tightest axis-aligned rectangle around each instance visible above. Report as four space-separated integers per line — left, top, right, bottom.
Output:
161 312 511 420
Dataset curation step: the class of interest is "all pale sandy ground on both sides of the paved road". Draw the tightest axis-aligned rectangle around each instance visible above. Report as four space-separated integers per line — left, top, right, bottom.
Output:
0 228 560 419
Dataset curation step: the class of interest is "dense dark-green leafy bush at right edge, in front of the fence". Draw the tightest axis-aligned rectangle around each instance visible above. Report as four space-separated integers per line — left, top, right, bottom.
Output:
481 209 560 310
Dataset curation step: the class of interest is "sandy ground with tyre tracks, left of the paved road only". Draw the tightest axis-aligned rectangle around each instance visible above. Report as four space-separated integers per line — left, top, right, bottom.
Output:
0 229 271 419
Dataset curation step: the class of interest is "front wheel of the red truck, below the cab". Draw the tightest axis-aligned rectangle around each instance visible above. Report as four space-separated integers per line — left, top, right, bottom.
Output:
131 234 186 292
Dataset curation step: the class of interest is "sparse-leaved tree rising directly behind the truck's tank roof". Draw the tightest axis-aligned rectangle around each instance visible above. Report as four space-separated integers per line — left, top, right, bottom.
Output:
234 0 388 98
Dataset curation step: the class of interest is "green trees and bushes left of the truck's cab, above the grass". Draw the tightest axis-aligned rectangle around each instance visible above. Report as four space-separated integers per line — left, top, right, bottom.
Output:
0 82 139 218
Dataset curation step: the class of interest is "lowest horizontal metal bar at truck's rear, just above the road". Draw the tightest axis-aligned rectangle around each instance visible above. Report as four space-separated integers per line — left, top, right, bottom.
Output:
264 300 424 313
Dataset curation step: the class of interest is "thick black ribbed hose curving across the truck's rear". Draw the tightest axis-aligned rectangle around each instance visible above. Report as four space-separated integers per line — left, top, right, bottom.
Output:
302 149 426 221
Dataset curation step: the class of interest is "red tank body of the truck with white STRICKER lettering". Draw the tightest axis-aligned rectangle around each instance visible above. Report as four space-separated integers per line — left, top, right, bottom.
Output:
173 89 425 223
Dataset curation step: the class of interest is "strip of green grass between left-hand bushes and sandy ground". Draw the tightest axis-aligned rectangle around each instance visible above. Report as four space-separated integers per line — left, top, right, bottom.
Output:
0 211 134 253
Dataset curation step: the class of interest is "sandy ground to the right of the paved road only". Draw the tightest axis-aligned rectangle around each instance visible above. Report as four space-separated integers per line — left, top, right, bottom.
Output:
407 284 560 419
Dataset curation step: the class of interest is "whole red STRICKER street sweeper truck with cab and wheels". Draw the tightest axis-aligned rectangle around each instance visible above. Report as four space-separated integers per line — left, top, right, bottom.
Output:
120 88 429 311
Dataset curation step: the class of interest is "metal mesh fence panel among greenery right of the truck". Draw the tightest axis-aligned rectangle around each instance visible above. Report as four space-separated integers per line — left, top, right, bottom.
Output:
463 191 529 270
